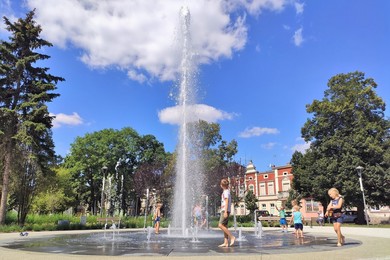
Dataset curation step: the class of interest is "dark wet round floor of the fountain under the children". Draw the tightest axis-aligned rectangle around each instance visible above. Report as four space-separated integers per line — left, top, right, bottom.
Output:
2 230 360 256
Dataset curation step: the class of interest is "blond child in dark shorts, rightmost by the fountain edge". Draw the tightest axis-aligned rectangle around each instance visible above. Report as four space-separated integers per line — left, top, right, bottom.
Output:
325 188 345 246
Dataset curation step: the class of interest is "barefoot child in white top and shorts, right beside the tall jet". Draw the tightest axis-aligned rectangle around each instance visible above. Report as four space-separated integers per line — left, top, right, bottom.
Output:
218 179 236 247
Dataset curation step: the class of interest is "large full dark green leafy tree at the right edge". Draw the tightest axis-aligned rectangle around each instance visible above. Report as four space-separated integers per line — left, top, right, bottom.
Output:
292 72 390 223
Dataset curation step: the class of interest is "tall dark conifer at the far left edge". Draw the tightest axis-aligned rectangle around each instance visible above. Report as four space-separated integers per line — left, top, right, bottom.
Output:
0 11 64 224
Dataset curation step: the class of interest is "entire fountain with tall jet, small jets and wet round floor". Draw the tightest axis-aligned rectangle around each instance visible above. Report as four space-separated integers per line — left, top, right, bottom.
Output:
0 8 359 257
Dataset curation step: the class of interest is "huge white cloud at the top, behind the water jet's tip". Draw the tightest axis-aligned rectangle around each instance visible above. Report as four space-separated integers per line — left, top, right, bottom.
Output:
26 0 291 82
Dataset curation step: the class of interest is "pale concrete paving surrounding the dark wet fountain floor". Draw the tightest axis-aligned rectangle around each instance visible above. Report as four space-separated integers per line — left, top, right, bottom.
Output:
0 226 390 260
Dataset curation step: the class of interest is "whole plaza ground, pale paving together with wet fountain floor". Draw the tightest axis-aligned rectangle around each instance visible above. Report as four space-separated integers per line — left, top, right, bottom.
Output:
0 226 390 260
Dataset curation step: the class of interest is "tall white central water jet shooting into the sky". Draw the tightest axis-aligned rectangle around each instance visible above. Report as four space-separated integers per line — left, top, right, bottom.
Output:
173 7 203 236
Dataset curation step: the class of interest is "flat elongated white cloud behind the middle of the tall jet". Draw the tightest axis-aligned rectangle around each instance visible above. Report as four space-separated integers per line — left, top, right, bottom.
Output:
158 104 235 125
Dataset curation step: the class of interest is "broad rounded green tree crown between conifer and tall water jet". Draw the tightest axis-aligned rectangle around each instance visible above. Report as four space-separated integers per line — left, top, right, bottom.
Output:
65 127 166 215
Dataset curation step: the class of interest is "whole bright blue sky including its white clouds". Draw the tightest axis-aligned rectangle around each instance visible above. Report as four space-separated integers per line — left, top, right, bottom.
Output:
0 0 390 171
